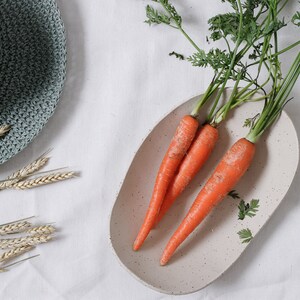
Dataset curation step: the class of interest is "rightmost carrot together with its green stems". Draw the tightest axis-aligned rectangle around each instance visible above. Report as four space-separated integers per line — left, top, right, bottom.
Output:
160 49 300 265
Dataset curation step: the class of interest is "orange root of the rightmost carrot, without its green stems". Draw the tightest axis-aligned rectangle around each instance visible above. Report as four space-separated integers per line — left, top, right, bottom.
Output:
160 138 255 266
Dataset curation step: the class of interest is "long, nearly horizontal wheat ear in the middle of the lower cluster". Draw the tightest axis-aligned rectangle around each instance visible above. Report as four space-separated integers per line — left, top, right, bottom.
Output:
0 234 52 249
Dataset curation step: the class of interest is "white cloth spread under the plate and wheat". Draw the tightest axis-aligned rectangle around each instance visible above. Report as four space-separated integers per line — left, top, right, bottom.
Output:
0 0 300 300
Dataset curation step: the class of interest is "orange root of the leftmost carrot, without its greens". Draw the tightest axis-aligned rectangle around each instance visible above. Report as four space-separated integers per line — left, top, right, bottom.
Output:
133 115 199 250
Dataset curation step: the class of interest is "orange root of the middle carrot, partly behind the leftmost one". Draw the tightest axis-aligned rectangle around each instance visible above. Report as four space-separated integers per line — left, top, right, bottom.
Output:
155 124 219 225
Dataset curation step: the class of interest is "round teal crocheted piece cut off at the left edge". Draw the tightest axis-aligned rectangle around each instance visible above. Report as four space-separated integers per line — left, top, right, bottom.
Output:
0 0 66 164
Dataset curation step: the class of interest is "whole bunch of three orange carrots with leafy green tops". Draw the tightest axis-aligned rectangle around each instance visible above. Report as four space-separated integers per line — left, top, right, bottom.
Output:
133 0 300 265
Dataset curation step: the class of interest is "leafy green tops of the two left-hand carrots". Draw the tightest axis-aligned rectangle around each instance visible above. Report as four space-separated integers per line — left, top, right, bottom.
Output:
145 0 298 127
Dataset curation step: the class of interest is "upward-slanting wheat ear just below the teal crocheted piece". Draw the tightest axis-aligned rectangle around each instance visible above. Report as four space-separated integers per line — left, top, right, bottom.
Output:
0 150 50 190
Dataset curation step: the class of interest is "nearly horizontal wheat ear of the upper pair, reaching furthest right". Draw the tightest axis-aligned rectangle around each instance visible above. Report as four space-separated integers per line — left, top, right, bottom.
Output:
10 172 77 190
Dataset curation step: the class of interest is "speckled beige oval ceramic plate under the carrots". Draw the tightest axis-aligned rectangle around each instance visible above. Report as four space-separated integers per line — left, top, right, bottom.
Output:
110 92 299 294
